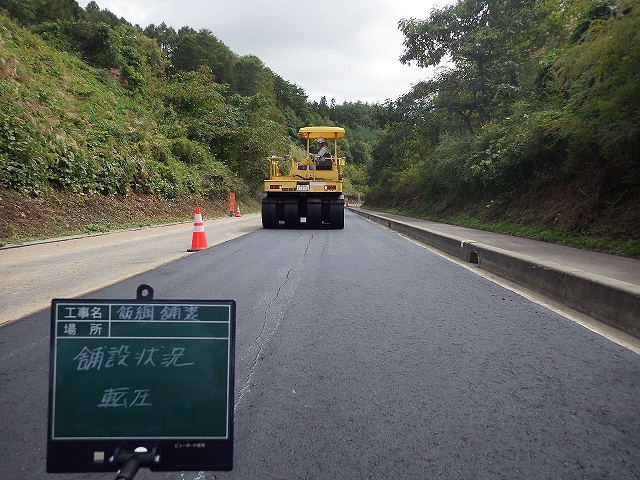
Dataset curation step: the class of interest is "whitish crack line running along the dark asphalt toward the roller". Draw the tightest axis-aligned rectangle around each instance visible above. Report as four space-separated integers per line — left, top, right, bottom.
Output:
233 235 313 413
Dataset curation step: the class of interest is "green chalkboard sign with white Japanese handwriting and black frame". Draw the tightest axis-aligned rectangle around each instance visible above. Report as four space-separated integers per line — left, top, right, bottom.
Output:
47 286 235 472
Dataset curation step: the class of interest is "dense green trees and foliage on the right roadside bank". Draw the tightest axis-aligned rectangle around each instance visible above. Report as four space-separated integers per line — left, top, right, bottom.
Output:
366 0 640 251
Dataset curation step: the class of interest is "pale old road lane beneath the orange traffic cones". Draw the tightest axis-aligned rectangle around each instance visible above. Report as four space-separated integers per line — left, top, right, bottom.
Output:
0 215 260 325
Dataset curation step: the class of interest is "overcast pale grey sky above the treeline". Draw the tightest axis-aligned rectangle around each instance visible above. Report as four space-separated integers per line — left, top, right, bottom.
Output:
78 0 454 104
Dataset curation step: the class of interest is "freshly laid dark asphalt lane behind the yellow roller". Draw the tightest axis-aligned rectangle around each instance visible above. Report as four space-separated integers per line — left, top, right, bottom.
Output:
0 212 640 480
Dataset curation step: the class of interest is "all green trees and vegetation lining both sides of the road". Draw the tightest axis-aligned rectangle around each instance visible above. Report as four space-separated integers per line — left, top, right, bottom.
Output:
0 0 640 256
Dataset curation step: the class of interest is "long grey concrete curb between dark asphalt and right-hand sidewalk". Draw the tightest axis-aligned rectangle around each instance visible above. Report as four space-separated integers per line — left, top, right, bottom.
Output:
351 209 640 338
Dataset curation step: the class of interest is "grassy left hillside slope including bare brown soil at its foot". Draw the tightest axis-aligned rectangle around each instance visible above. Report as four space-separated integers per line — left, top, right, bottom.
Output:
0 14 262 243
